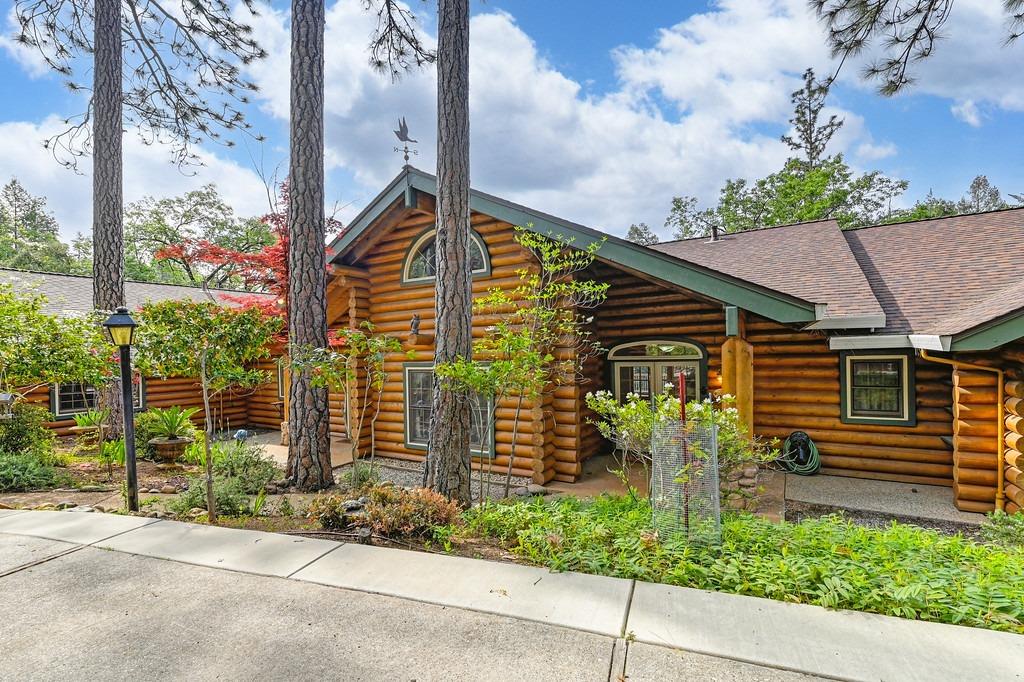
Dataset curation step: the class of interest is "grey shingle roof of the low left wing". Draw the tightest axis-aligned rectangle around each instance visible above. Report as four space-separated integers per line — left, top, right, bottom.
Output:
0 268 270 314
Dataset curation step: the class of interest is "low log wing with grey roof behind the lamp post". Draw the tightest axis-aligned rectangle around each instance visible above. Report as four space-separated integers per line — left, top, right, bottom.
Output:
0 268 284 435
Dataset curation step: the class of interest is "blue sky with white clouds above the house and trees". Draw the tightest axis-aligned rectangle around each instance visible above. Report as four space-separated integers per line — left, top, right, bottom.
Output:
0 0 1024 238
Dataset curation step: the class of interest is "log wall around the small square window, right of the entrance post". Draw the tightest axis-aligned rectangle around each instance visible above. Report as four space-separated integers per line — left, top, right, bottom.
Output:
746 315 953 485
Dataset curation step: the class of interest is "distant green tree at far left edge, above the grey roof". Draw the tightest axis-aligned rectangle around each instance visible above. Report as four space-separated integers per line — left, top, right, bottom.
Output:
0 178 72 272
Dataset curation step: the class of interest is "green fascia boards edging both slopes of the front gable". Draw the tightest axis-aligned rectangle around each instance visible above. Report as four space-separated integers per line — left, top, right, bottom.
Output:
331 167 817 324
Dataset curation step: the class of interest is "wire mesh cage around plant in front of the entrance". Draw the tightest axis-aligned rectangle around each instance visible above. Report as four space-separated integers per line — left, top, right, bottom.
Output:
650 419 722 544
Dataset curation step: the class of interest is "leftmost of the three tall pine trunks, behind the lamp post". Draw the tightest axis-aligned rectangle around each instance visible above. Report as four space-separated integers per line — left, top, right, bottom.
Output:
92 0 130 438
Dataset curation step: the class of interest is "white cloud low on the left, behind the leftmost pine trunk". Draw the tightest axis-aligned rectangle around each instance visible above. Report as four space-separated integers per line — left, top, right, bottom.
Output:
0 116 267 238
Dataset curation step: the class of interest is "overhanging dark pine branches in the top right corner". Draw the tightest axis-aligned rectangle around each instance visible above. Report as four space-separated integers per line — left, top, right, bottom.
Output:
810 0 1024 95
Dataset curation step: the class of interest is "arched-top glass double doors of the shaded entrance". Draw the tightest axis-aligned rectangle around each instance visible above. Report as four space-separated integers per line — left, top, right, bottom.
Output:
608 339 708 401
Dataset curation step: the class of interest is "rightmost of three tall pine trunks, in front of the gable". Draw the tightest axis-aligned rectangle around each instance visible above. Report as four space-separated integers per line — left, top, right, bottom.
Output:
423 0 473 504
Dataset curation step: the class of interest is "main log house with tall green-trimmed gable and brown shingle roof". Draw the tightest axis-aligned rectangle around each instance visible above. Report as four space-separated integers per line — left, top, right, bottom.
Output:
328 166 1024 511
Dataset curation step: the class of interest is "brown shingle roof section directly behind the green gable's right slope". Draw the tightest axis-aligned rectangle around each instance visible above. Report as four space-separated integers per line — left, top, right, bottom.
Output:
651 220 883 318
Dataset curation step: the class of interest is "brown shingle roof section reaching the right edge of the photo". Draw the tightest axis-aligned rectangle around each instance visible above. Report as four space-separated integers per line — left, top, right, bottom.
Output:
845 209 1024 335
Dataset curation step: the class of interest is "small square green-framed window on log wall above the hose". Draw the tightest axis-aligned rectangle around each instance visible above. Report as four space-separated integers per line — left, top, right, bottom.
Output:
840 352 916 426
